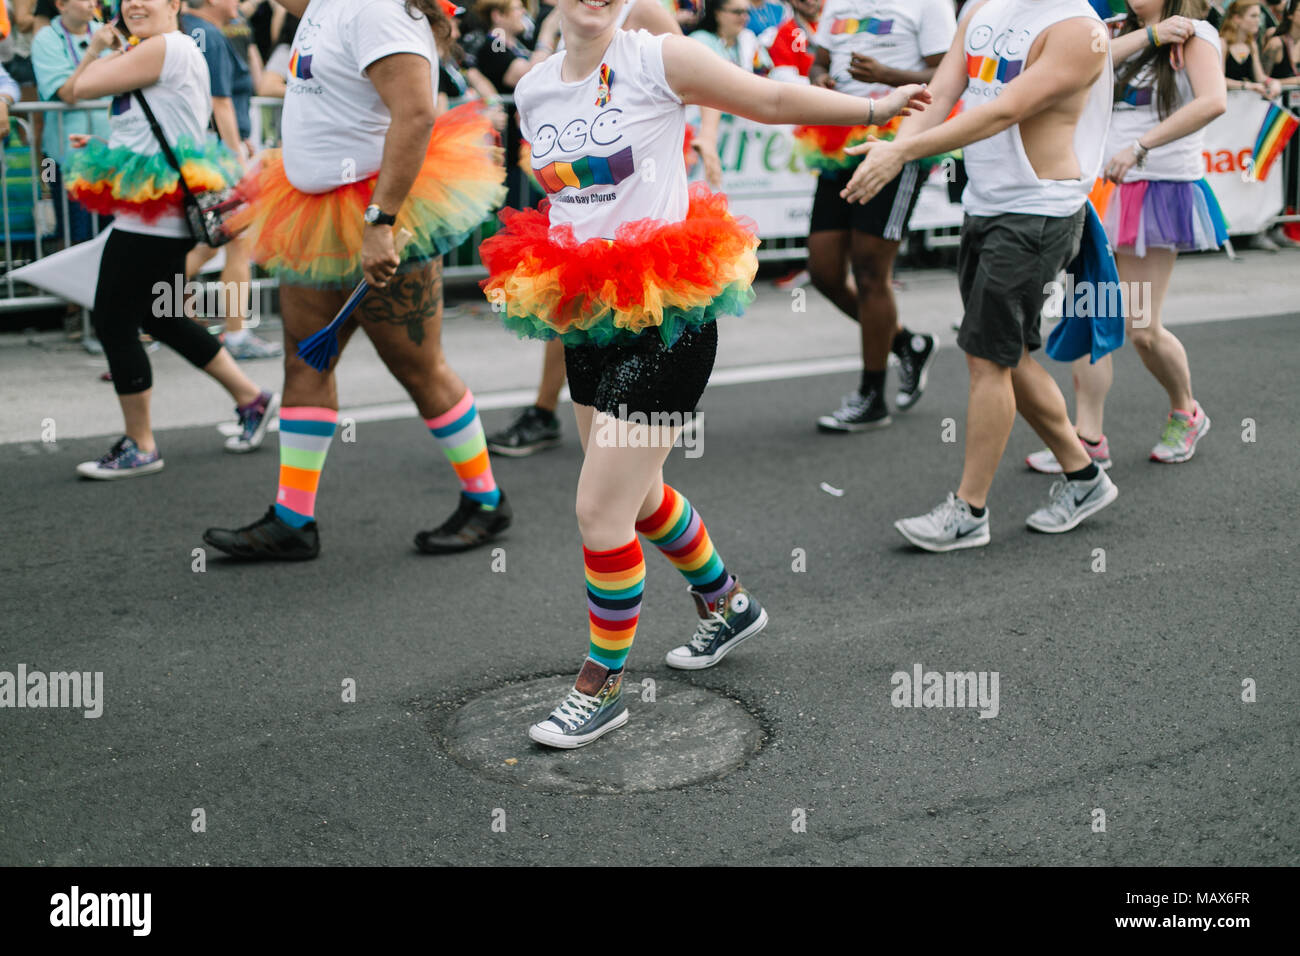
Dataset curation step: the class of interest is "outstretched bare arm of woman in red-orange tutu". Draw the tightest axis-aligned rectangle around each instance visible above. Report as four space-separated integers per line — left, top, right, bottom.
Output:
663 36 931 126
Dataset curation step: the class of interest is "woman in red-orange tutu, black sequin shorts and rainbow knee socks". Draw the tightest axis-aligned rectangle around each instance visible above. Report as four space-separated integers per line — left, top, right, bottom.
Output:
480 0 930 748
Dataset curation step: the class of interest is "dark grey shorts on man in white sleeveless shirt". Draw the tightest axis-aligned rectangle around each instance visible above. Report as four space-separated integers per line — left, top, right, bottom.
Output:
957 207 1086 368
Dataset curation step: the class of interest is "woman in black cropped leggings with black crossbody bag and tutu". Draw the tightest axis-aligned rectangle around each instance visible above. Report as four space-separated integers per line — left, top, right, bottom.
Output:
68 0 278 479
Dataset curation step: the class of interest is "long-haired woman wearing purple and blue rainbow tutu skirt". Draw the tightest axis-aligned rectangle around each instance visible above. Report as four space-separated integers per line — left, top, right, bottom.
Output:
1026 0 1227 473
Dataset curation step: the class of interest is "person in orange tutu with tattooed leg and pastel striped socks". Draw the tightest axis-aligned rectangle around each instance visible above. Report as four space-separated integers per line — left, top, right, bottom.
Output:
203 0 511 561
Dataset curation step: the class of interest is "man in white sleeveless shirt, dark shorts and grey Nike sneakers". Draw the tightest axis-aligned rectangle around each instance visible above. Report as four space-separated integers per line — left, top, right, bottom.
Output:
845 0 1118 551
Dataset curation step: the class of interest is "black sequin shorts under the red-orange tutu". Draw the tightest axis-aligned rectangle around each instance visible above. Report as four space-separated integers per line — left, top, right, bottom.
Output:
564 323 718 419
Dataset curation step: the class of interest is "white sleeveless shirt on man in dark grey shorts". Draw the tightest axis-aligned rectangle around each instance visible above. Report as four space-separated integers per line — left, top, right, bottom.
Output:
962 0 1114 217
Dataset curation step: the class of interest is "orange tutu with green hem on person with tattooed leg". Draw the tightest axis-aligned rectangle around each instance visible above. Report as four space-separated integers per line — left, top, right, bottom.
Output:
231 103 506 289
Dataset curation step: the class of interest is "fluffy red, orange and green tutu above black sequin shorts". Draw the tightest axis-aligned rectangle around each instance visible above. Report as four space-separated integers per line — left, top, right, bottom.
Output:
478 182 758 346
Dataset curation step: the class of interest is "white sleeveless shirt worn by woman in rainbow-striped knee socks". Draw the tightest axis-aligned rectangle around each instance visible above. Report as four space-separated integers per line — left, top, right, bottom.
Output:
515 30 688 242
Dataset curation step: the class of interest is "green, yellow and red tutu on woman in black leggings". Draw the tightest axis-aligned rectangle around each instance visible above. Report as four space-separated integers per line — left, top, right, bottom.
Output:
68 137 239 222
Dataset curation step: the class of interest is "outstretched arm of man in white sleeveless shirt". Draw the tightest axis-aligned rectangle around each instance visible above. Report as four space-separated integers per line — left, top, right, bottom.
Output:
841 17 1110 203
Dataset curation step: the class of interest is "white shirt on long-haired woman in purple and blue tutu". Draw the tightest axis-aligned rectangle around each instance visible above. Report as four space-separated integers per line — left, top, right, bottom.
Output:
1105 20 1222 182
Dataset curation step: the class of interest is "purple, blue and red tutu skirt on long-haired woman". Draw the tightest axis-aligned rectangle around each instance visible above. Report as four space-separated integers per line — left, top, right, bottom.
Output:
1093 179 1227 256
